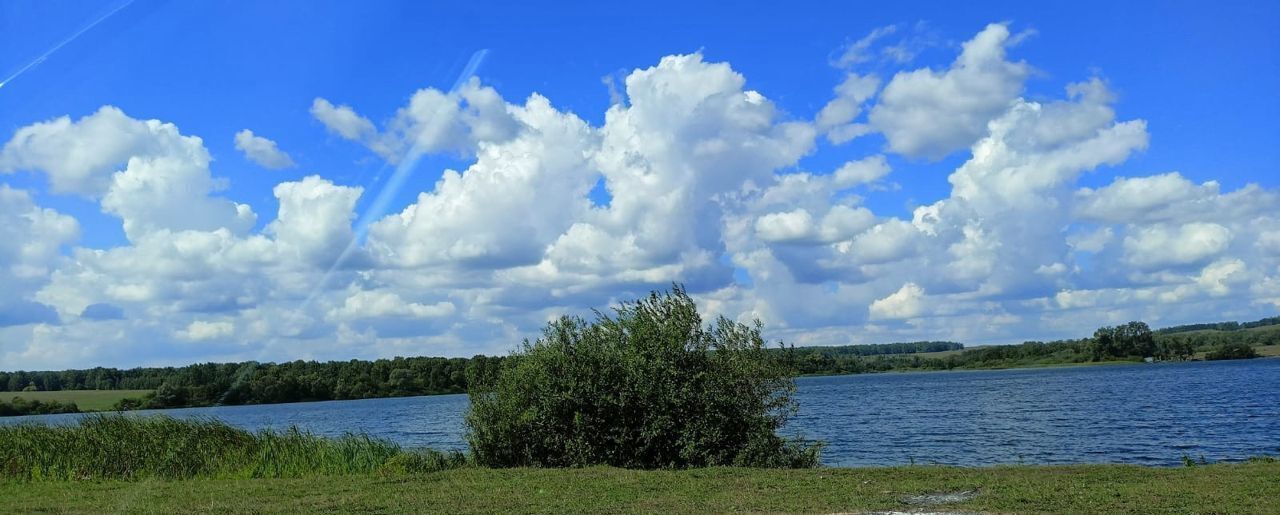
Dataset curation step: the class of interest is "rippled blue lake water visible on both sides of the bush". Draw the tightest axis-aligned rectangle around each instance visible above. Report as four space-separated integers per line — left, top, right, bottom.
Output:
0 359 1280 466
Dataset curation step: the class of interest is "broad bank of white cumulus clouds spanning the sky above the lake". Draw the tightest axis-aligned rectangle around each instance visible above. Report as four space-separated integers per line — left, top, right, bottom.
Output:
0 24 1280 368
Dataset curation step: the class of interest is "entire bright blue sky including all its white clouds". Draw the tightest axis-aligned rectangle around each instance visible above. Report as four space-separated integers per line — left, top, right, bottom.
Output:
0 0 1280 370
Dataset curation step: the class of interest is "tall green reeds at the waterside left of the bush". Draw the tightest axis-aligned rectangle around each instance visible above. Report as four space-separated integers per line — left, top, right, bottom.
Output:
0 414 467 480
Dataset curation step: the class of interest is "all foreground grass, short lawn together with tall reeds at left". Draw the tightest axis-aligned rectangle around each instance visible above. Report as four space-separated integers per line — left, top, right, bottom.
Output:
0 415 1280 512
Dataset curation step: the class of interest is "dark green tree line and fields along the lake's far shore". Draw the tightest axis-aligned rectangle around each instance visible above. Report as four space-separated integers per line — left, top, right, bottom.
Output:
0 311 1280 416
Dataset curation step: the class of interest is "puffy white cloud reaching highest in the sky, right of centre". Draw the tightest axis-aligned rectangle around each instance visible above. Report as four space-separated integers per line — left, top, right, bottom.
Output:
870 24 1030 159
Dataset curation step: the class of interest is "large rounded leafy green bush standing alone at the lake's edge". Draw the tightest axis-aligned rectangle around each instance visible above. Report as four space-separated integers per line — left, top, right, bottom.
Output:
466 286 819 469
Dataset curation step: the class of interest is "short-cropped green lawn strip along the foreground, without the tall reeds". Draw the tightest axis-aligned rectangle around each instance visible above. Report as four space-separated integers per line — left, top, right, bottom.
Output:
0 462 1280 514
